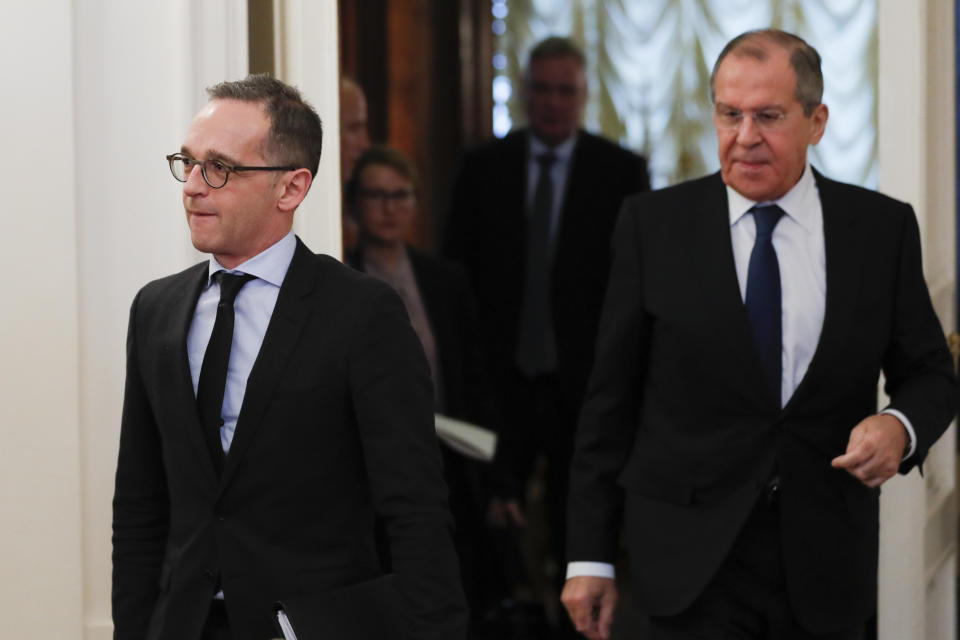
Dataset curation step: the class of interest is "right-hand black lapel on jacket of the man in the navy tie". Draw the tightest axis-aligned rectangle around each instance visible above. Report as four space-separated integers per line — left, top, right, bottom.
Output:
785 170 864 410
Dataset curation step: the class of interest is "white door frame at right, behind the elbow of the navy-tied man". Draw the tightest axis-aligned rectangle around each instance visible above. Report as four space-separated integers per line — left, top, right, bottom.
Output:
878 0 957 640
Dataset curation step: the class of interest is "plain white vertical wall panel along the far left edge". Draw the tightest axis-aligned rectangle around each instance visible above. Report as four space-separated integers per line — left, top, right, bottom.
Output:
0 0 83 638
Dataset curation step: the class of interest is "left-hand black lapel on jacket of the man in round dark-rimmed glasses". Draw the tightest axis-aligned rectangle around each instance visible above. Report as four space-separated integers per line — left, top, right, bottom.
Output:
162 262 217 484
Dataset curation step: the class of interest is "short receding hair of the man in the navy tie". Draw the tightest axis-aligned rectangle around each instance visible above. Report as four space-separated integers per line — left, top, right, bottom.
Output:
710 29 823 116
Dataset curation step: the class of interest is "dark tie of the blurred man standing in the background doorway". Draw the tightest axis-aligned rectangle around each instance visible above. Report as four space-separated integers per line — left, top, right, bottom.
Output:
517 151 557 376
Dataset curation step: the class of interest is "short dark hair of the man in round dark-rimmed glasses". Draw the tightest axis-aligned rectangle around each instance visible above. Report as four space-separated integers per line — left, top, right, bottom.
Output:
207 73 323 177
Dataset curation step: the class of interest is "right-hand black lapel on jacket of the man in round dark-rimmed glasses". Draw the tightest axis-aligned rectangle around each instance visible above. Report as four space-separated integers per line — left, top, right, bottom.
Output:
220 238 315 491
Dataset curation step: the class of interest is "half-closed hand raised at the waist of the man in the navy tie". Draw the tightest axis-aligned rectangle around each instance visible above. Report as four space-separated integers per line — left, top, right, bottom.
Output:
830 413 907 488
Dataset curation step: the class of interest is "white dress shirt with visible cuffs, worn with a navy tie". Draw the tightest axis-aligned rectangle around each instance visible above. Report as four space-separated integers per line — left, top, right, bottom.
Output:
567 164 917 578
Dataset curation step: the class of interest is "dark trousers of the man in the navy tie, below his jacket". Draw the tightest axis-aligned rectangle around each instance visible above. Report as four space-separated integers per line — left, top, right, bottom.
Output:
649 496 864 640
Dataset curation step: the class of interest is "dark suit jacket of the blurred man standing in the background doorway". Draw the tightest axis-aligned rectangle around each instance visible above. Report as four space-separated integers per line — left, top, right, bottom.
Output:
443 130 650 490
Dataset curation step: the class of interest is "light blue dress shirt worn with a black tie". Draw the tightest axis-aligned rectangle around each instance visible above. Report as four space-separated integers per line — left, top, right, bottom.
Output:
187 231 297 453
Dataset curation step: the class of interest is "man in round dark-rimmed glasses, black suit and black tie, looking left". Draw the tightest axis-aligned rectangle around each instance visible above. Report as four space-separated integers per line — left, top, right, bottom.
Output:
113 76 466 640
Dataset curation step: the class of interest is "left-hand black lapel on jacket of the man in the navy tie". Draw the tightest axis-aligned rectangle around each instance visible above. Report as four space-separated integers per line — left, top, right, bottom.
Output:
687 173 774 406
